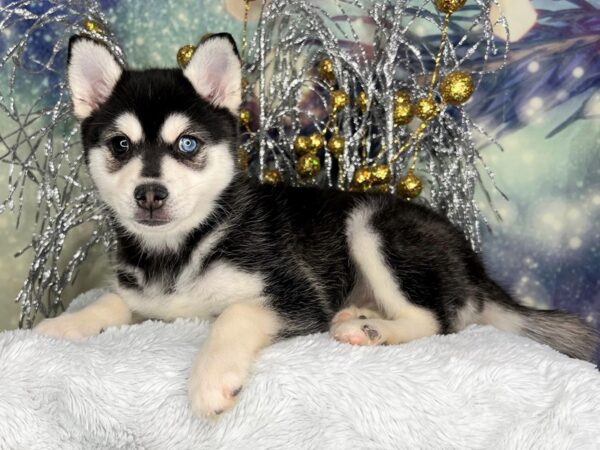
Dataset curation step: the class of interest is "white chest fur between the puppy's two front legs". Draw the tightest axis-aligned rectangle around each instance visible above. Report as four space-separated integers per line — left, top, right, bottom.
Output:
118 262 264 320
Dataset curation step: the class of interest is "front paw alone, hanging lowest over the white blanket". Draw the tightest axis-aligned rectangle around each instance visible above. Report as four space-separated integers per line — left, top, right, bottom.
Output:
189 349 250 417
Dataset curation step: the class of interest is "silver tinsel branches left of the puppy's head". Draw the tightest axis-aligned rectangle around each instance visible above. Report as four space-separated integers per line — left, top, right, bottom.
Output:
0 0 123 327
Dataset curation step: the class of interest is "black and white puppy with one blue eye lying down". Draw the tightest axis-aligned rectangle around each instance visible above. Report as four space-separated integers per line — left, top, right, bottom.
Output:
37 34 595 415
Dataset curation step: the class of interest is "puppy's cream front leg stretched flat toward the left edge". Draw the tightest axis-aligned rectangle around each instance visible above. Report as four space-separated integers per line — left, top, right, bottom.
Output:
34 293 131 339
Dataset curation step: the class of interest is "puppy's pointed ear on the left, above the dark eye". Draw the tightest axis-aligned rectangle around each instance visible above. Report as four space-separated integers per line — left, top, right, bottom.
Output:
68 36 123 120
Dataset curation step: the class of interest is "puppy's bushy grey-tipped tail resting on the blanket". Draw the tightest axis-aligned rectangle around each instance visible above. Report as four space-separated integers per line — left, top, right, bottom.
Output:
480 286 599 361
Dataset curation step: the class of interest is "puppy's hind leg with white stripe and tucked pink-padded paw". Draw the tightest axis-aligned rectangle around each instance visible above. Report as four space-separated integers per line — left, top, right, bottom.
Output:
342 205 440 345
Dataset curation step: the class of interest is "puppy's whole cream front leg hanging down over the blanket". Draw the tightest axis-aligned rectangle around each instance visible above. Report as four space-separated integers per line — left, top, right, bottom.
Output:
189 303 281 416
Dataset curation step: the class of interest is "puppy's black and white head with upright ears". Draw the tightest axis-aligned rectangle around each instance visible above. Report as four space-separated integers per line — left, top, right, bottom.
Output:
68 34 241 247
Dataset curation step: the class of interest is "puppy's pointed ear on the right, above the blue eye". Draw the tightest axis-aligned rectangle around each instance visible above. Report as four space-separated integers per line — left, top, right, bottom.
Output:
183 33 242 116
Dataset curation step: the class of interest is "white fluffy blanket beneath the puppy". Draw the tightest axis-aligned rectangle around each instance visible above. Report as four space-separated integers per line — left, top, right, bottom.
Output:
0 294 600 450
